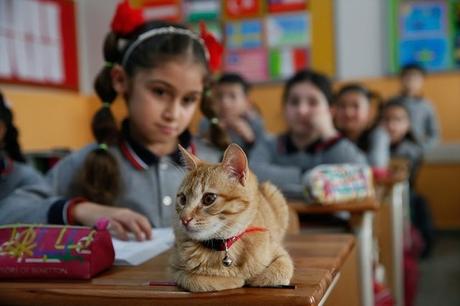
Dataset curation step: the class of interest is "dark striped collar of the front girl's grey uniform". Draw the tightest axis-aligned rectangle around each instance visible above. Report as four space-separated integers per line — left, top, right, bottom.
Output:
119 120 195 170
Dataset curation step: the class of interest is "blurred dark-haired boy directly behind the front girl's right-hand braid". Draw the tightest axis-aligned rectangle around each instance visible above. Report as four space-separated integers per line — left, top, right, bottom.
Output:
199 73 265 154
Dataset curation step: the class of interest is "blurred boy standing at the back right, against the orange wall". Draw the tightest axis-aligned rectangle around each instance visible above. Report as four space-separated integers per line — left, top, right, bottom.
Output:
394 64 439 151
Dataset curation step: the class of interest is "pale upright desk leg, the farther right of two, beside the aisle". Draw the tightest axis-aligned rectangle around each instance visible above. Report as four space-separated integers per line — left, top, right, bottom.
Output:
391 183 409 306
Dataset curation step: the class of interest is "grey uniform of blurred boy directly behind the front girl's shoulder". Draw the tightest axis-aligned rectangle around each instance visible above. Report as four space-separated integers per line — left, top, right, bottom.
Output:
198 112 266 155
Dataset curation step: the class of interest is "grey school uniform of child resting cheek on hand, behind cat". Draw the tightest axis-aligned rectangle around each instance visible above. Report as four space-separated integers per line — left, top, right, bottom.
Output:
249 133 366 198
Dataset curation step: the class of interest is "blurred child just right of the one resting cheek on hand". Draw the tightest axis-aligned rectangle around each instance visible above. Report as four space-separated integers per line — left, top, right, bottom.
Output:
333 84 390 168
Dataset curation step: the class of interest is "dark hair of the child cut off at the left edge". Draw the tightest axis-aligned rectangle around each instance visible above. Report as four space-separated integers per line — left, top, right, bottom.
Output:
0 93 26 162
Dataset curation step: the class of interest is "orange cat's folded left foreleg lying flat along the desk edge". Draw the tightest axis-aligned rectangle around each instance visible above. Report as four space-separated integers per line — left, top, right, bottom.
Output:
174 271 244 292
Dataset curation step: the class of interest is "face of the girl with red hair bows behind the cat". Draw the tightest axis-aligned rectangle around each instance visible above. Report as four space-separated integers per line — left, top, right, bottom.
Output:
115 61 204 144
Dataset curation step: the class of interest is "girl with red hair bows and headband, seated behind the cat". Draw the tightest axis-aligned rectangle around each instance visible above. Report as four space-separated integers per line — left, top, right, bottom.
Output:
47 1 220 240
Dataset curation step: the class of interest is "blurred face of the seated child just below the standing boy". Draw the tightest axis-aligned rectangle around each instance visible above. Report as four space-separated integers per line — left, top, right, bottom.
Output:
382 106 410 144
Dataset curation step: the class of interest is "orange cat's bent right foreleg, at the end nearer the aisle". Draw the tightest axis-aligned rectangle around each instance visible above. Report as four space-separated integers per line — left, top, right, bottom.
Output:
247 246 294 287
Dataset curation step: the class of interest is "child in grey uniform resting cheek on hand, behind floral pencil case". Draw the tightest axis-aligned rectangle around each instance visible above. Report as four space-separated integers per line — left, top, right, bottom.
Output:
249 70 366 198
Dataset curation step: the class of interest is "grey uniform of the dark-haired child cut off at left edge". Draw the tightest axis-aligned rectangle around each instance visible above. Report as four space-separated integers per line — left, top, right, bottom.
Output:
0 154 68 224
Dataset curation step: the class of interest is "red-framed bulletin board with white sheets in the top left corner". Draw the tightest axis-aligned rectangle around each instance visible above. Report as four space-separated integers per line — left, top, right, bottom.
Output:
0 0 78 90
